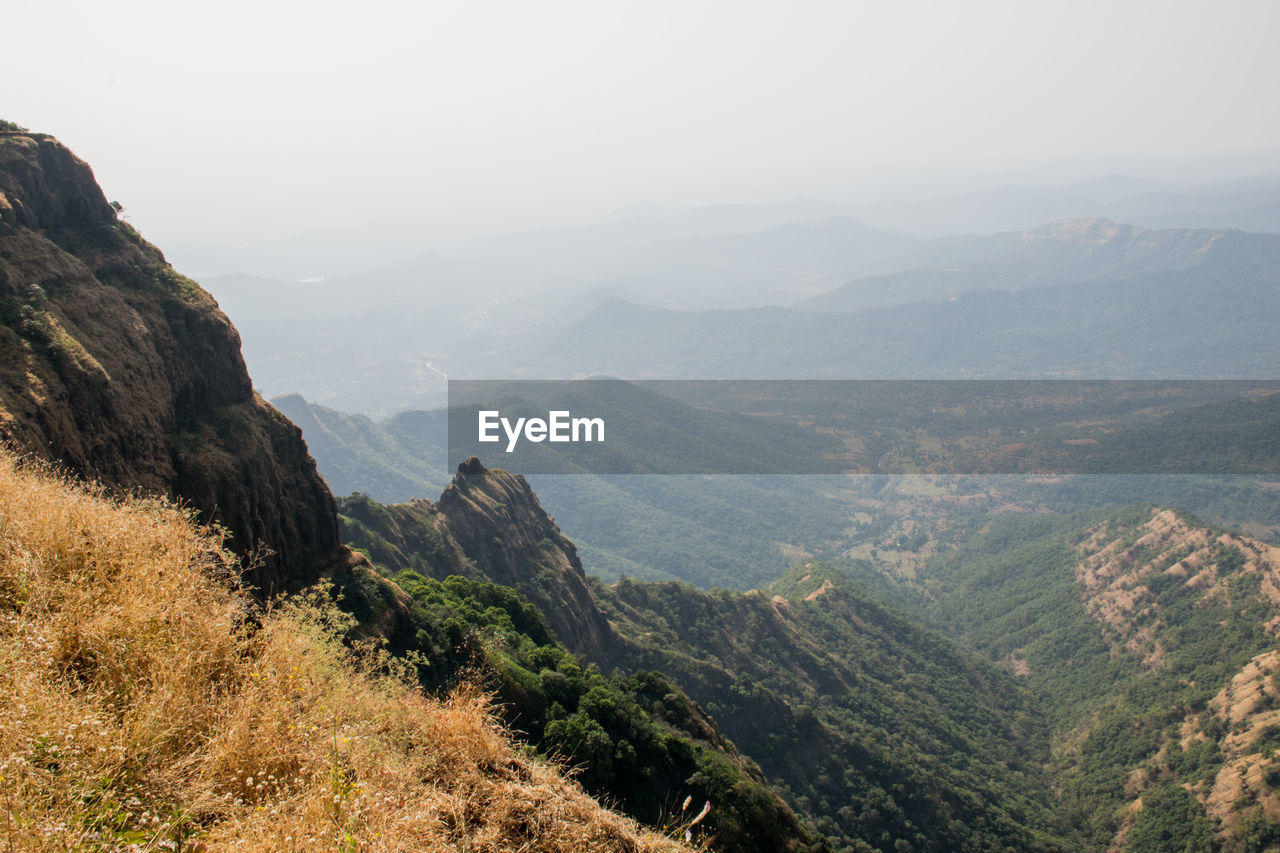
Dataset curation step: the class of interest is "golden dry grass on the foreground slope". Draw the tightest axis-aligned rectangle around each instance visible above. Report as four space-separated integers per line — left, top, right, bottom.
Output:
0 455 677 852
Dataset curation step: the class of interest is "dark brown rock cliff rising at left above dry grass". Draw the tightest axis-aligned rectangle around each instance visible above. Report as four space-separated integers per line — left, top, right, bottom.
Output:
0 132 343 592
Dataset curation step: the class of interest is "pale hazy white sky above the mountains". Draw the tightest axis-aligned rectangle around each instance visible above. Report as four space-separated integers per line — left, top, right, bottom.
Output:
0 0 1280 245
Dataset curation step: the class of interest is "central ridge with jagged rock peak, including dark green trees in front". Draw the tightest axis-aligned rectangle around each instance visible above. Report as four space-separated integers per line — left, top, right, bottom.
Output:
339 460 1062 850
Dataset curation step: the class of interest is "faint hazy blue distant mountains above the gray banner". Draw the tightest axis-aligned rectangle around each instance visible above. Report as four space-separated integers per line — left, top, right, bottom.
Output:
210 208 1280 416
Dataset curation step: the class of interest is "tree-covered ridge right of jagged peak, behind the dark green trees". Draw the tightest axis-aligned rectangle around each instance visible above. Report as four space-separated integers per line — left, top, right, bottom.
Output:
595 564 1064 850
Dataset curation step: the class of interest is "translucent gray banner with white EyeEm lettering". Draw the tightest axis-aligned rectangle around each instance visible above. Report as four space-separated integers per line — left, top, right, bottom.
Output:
448 379 1280 475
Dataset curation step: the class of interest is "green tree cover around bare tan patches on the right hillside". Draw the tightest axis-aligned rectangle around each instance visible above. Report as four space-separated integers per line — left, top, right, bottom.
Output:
916 506 1277 850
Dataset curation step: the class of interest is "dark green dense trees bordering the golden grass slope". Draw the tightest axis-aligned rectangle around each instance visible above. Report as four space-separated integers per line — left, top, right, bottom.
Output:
340 560 822 850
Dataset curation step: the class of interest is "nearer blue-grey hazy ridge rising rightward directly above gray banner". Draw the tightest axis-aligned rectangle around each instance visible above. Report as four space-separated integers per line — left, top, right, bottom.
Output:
530 219 1280 379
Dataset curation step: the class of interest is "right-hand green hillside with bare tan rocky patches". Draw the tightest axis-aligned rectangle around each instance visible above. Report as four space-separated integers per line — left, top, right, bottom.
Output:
923 507 1280 850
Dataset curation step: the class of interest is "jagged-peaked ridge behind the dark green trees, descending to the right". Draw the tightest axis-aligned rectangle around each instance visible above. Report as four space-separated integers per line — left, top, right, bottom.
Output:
340 460 1061 850
